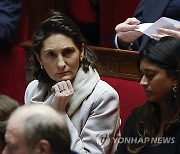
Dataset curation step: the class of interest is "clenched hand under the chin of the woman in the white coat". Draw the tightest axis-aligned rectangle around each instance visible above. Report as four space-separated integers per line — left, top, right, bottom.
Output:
51 80 74 114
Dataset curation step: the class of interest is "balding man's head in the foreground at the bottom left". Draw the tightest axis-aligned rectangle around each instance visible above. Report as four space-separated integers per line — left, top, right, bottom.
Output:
3 104 74 154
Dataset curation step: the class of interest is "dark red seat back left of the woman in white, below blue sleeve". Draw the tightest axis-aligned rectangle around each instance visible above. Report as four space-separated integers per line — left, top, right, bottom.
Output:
0 45 26 103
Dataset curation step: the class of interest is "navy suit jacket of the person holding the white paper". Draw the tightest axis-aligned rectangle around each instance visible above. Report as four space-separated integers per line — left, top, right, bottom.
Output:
132 0 180 51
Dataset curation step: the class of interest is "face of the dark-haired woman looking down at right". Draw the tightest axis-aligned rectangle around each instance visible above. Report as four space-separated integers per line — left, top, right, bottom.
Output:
140 59 176 103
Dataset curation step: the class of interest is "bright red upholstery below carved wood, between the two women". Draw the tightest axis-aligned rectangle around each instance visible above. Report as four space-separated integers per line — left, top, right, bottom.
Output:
101 76 145 131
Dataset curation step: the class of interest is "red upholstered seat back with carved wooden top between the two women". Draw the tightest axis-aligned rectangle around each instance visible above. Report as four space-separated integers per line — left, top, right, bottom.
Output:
90 46 146 131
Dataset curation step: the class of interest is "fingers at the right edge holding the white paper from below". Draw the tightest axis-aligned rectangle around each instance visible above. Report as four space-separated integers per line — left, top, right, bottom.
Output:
151 25 180 40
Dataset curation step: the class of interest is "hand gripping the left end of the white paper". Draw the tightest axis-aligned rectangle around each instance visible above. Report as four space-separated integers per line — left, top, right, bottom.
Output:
115 17 143 47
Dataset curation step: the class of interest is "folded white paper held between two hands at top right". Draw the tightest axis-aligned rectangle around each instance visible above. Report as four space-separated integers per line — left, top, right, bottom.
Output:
136 17 180 36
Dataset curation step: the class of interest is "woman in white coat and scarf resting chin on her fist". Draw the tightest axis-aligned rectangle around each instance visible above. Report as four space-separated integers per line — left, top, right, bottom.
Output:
25 12 119 153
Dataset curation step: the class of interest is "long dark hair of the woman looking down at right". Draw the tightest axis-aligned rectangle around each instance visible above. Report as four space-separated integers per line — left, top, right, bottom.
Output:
127 37 180 153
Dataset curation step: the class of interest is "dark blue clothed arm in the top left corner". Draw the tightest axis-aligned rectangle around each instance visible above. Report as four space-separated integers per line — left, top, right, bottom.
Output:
0 0 21 46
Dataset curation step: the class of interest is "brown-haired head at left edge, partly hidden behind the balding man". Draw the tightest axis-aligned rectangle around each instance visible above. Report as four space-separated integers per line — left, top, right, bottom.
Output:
0 95 19 153
